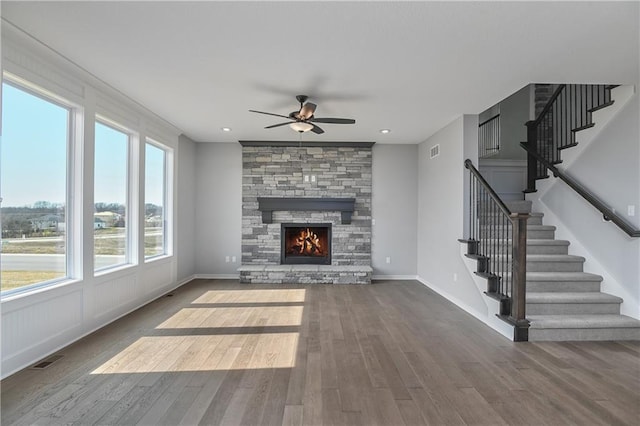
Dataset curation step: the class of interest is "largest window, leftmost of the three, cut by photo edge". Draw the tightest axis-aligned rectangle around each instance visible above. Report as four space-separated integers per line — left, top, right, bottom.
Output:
0 81 71 293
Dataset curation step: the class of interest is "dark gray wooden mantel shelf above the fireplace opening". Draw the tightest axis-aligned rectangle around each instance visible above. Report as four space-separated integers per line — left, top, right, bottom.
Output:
258 197 356 225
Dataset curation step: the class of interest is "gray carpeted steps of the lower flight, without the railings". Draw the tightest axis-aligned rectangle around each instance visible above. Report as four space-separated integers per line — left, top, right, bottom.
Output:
503 201 640 341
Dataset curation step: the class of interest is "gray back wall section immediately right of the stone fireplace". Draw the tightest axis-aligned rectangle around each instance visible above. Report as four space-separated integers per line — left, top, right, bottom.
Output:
371 144 418 278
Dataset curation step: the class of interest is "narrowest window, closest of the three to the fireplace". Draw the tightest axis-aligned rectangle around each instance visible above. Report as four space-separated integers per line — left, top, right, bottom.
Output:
144 141 168 259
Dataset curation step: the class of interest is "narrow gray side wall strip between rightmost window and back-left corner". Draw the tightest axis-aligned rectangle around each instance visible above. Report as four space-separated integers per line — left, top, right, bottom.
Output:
175 135 196 282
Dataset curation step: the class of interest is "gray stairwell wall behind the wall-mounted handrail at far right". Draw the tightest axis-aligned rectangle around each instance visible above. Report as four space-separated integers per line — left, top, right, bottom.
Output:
540 93 640 317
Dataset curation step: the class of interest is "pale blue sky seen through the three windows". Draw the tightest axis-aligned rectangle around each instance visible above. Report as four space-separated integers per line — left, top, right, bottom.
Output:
0 83 164 207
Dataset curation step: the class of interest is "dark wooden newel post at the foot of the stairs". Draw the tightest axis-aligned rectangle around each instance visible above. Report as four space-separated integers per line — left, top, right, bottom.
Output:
509 213 529 342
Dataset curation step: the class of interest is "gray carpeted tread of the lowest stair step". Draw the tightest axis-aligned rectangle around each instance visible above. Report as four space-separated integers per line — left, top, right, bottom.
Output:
527 314 640 329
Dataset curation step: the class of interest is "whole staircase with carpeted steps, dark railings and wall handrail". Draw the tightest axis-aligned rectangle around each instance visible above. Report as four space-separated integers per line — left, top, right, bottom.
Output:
460 84 640 341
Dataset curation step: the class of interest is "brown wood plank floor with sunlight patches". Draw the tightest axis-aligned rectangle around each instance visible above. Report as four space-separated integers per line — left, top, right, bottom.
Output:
1 280 640 426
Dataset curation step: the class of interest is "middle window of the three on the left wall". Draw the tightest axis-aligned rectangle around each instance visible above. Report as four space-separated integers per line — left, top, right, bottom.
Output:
93 122 129 271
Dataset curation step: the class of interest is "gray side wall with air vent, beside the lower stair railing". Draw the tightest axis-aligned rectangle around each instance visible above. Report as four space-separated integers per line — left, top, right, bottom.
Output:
417 116 488 316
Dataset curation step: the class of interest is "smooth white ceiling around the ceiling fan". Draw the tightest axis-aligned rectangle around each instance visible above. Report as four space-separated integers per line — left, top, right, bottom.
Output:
1 1 640 143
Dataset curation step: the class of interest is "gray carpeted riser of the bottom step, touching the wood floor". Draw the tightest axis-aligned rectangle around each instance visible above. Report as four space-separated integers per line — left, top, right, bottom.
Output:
529 328 640 342
